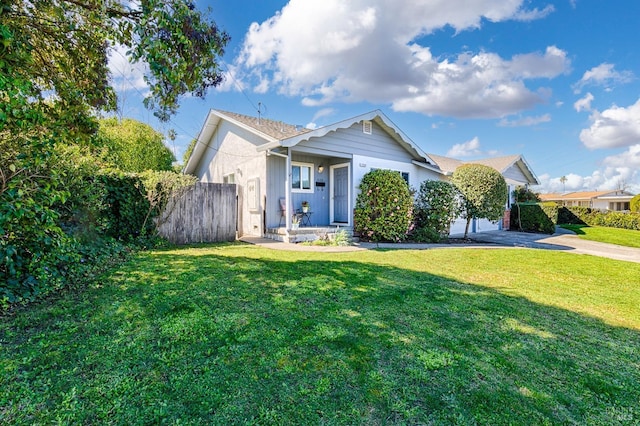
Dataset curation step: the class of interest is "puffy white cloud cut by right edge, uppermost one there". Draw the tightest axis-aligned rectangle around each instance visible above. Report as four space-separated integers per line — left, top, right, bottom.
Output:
580 99 640 149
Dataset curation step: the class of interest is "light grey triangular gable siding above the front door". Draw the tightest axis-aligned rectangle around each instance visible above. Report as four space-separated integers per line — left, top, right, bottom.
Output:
296 122 414 162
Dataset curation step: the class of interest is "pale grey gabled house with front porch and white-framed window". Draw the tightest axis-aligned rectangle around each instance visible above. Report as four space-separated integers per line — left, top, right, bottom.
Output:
184 110 443 241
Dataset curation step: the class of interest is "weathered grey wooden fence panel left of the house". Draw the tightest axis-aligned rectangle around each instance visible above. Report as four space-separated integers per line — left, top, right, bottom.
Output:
158 183 238 244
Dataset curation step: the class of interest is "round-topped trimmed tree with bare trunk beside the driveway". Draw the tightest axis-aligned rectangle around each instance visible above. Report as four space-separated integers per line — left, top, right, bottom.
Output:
452 164 507 238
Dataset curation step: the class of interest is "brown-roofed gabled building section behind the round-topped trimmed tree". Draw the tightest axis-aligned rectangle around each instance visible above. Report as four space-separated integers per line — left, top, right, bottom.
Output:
429 154 540 234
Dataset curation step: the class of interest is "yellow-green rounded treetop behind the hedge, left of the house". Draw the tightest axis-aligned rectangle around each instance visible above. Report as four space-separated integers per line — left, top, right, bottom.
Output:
96 118 175 173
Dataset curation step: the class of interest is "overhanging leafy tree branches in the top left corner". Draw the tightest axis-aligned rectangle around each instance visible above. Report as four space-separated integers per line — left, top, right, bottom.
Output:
2 0 229 120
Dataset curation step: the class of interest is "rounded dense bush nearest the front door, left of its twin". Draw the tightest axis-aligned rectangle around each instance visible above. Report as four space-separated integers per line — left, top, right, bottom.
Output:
354 169 413 241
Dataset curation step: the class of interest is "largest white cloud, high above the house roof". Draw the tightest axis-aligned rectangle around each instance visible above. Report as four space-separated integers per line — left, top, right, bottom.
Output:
237 0 569 117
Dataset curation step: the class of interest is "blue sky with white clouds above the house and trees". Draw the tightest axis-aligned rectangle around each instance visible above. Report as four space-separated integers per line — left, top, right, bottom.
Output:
111 0 640 193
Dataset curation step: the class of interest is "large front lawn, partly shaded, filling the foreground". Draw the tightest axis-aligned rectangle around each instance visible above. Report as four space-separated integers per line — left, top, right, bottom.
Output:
0 244 640 425
